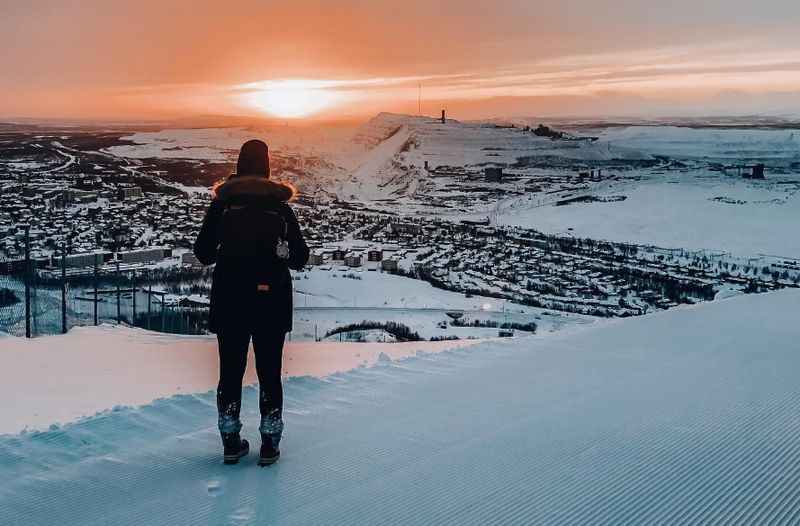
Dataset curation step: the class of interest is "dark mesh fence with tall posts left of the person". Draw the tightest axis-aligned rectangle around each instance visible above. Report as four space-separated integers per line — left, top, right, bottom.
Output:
0 238 208 338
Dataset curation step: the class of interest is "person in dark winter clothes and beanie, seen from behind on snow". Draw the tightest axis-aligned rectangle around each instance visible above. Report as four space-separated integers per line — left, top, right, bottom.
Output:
194 140 308 466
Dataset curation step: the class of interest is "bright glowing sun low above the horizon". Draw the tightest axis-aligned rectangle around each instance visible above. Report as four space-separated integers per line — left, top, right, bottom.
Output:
242 79 344 119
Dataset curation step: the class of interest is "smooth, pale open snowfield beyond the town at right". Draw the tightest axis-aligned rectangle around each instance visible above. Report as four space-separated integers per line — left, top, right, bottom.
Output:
498 172 800 258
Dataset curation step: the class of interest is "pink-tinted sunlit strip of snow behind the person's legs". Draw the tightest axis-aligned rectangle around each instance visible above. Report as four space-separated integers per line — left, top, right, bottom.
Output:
0 325 474 434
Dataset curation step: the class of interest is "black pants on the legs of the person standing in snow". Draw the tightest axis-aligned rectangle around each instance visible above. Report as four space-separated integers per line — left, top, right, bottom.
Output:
217 331 286 433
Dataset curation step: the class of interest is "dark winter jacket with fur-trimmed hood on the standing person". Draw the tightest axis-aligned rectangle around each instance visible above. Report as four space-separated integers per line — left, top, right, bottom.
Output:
194 176 308 334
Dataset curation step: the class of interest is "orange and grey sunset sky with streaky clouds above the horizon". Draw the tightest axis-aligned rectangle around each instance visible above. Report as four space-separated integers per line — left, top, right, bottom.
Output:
0 0 800 119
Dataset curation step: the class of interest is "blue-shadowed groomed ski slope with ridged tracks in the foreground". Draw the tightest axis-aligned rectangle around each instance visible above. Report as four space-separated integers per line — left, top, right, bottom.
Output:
0 290 800 526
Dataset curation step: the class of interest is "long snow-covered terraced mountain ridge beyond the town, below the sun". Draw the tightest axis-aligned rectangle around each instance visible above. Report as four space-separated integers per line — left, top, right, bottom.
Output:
95 113 800 258
